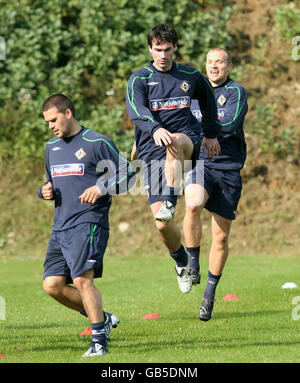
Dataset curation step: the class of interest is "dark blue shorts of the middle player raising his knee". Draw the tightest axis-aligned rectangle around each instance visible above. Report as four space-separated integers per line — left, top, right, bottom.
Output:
142 136 200 205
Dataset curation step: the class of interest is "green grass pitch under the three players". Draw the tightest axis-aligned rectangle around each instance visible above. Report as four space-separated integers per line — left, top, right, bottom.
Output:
0 255 300 363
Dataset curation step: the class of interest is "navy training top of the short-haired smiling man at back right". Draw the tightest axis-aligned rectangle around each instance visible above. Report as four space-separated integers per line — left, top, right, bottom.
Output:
191 78 248 170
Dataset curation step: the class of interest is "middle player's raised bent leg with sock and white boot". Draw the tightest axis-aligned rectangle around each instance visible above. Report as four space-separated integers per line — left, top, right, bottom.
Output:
155 133 194 222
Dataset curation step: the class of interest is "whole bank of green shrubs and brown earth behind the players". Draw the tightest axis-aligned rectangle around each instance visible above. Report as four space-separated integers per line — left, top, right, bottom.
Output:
0 0 300 255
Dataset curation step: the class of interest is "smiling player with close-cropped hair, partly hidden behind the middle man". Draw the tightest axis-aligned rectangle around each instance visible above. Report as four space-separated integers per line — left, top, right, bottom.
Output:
184 48 248 321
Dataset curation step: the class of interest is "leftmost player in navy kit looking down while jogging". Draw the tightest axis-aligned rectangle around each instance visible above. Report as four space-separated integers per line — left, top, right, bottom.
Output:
39 94 134 356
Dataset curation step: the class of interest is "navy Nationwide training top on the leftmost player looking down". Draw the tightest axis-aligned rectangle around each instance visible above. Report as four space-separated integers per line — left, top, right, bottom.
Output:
38 127 133 231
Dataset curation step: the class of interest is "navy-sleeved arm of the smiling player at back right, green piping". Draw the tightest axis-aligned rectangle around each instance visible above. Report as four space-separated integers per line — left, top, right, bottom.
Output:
220 86 248 135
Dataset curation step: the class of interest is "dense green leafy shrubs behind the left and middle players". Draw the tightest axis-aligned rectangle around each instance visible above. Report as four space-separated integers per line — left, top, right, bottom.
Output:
0 0 239 161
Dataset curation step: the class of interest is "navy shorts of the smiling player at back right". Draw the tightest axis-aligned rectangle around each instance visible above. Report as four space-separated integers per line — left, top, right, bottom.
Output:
185 166 242 220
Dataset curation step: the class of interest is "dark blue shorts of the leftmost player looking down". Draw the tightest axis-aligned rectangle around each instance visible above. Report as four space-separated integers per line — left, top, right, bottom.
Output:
43 223 109 283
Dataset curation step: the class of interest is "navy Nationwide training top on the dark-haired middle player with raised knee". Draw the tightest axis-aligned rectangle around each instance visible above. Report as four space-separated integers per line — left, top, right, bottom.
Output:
126 61 221 163
